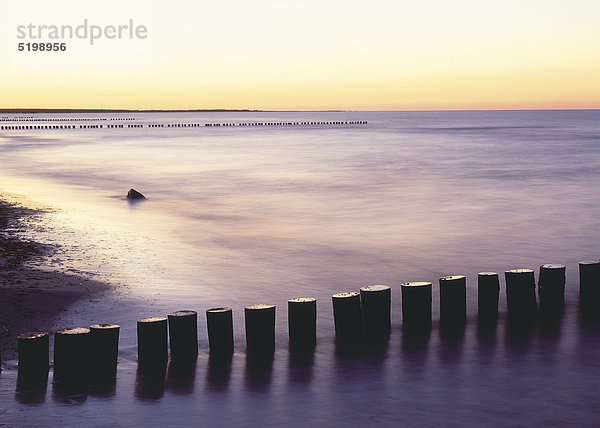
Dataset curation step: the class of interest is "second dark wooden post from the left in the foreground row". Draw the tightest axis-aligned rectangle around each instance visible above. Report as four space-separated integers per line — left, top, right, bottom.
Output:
54 327 91 380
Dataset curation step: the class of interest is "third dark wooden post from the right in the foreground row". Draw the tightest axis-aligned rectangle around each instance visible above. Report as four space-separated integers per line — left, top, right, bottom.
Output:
504 269 537 318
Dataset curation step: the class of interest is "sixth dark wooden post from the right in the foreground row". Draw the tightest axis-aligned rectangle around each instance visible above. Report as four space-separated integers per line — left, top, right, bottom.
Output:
400 281 431 329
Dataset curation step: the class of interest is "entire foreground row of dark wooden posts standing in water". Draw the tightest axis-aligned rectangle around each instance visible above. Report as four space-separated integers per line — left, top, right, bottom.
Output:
8 261 600 377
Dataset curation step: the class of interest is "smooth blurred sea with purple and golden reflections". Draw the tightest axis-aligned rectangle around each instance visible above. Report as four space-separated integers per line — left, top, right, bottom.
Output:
0 111 600 425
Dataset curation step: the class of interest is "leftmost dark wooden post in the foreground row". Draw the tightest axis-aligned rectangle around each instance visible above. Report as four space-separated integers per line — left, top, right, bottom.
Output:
17 331 50 377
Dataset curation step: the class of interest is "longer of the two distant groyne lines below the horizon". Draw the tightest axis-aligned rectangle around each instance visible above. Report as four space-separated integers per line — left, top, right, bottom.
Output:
0 118 368 131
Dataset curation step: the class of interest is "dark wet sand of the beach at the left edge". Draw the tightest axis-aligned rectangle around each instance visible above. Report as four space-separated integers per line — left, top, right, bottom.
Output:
0 199 109 360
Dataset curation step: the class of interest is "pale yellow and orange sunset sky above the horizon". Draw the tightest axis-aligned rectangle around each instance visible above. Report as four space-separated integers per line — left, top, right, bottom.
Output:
0 0 600 110
